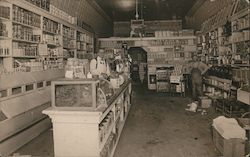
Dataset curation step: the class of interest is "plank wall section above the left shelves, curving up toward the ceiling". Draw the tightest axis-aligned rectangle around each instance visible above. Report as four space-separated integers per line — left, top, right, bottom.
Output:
51 0 113 37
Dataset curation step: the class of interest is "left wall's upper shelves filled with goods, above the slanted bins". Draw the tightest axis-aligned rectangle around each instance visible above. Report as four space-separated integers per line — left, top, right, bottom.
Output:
0 0 94 72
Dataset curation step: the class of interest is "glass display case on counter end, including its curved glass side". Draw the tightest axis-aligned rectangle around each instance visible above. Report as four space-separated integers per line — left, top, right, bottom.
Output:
51 78 115 109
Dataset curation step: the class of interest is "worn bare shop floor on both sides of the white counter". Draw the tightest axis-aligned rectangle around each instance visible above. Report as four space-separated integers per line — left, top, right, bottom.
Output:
17 86 220 157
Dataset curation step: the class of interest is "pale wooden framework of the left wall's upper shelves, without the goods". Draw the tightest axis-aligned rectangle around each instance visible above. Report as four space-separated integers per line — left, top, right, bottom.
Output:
0 0 93 72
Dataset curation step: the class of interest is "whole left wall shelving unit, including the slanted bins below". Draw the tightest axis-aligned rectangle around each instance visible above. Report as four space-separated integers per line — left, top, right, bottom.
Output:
0 0 94 156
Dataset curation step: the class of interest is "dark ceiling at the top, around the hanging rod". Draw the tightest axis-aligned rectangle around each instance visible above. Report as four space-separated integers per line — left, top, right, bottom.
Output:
95 0 197 21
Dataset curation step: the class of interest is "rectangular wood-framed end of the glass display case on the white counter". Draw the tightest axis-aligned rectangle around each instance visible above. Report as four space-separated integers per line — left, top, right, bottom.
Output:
51 79 99 109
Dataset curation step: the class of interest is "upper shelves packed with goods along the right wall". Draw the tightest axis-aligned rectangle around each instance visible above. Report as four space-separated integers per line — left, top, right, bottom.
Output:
198 0 250 66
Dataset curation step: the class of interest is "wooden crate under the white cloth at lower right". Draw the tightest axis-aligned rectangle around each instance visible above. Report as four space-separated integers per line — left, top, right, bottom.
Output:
213 128 245 157
